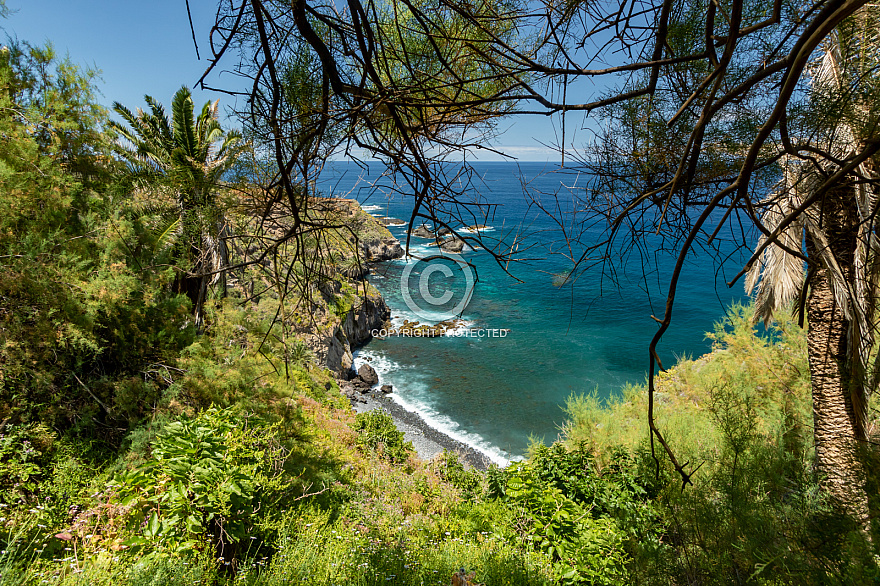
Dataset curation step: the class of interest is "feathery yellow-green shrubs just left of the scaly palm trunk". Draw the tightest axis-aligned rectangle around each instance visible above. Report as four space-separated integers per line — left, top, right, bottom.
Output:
556 307 878 585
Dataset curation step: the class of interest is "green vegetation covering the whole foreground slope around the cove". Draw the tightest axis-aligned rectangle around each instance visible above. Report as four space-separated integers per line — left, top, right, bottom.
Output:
0 16 880 586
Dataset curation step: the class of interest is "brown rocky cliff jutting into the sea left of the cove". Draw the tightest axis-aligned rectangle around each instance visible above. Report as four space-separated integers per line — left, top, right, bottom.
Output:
229 197 404 380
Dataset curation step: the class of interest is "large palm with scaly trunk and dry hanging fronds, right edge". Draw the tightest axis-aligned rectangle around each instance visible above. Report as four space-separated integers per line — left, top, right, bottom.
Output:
746 7 880 528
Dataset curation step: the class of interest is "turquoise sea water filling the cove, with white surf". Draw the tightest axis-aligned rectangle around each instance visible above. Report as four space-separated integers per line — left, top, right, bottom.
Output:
319 163 743 463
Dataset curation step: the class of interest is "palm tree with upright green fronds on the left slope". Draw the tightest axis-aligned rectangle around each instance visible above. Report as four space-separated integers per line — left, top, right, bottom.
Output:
111 86 247 327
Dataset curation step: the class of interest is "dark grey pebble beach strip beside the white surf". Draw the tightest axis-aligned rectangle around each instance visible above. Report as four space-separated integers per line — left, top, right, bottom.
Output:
349 389 502 472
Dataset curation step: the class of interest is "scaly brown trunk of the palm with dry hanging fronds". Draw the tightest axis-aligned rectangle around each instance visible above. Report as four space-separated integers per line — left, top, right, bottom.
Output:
807 185 869 529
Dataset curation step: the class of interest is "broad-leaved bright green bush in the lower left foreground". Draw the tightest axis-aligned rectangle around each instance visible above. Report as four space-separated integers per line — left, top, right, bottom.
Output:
117 408 291 559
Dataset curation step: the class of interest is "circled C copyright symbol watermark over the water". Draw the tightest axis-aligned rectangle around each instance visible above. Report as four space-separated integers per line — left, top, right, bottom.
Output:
400 253 475 322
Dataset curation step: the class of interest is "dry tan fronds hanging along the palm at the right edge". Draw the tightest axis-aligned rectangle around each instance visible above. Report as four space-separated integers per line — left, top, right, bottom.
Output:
746 7 880 428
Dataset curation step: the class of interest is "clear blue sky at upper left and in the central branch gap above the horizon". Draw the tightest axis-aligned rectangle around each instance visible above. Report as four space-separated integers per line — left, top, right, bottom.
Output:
0 0 574 161
